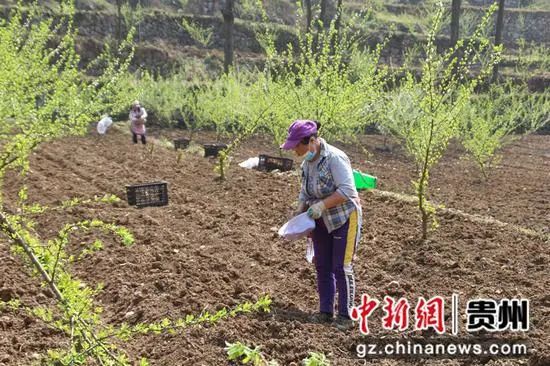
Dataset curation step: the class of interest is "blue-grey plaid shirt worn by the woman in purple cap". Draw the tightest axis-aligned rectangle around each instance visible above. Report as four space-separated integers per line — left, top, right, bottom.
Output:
298 139 359 233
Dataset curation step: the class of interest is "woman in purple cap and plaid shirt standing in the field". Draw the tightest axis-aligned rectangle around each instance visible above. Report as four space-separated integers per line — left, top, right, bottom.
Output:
281 120 361 330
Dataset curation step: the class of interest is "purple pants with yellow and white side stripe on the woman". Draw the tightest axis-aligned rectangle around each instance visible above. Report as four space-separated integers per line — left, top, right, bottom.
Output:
312 211 358 317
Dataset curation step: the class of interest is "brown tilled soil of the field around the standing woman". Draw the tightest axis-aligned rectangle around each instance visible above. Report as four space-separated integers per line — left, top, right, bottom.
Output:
0 130 550 365
